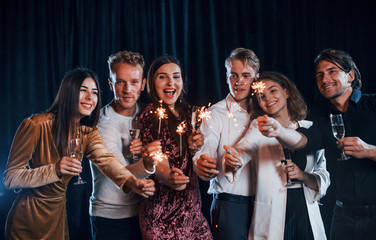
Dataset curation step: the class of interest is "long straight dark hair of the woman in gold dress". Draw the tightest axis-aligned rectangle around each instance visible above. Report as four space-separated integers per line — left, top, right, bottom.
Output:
48 68 101 156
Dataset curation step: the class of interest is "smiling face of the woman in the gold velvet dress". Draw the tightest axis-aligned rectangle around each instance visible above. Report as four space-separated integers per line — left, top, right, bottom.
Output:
78 78 99 118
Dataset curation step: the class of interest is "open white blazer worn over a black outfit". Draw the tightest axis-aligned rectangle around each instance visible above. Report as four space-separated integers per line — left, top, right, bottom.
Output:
227 120 330 240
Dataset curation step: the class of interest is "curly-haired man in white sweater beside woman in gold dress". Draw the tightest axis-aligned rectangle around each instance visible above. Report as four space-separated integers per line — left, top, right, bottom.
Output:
89 51 153 240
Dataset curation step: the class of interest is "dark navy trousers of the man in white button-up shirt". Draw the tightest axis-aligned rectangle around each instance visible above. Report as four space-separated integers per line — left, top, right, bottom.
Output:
210 193 254 240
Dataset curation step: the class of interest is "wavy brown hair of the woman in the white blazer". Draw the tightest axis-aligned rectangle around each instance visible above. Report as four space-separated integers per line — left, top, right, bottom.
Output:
252 72 307 121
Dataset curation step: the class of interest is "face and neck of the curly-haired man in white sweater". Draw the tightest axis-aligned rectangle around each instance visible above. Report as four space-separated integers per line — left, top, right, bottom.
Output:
108 63 145 116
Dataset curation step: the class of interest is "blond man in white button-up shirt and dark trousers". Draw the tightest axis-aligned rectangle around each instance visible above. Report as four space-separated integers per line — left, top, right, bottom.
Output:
193 48 260 240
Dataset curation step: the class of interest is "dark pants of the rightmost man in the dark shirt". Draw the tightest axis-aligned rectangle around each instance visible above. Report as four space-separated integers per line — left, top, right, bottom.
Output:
330 201 376 240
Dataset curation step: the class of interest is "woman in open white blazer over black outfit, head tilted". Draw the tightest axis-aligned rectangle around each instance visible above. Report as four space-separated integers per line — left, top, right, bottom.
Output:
224 72 330 240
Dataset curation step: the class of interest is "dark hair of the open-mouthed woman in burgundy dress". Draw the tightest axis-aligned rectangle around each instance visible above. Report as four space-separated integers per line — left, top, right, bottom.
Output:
146 56 186 150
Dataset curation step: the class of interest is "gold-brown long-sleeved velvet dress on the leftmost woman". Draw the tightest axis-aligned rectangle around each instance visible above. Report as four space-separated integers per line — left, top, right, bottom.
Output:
4 113 132 240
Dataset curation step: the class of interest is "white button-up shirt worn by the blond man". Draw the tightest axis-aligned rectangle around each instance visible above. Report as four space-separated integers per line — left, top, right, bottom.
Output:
193 94 255 196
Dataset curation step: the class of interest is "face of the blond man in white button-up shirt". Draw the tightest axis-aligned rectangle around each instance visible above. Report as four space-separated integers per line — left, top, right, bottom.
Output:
227 59 256 109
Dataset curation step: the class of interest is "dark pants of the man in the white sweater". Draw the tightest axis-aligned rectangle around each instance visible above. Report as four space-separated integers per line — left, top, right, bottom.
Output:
90 216 141 240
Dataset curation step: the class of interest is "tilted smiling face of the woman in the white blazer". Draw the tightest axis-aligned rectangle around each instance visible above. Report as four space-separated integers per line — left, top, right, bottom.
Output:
257 79 289 118
